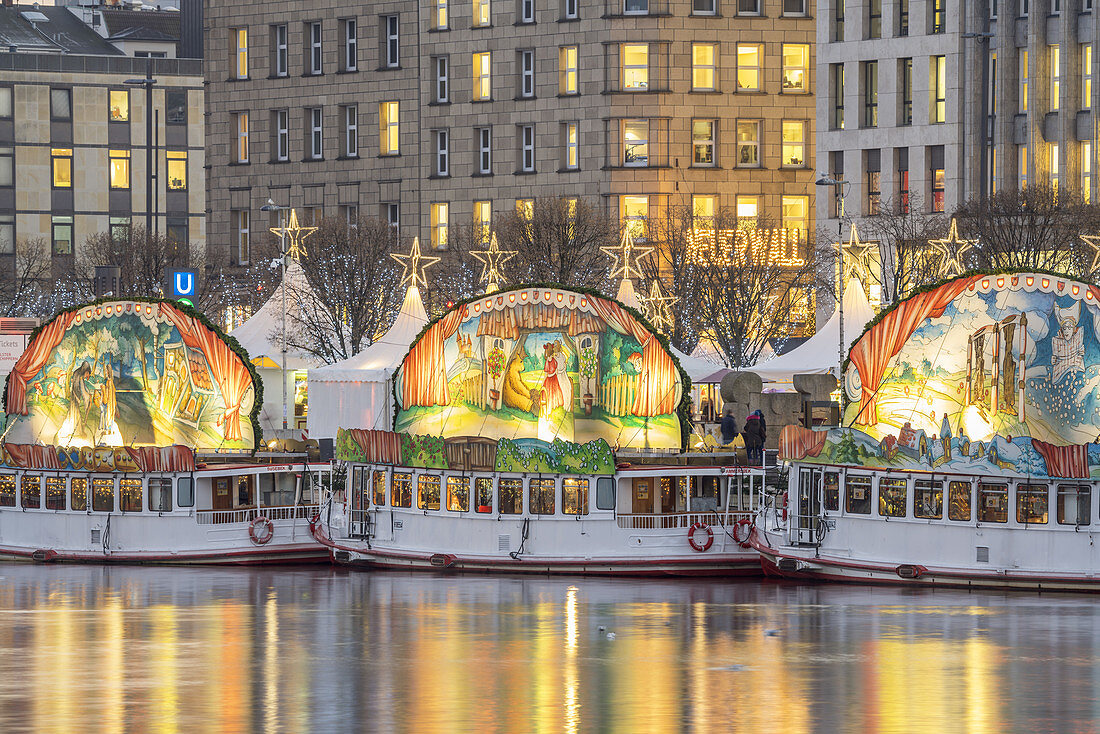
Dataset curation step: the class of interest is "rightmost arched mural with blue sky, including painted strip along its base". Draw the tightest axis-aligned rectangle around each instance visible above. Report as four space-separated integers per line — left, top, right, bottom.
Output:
781 273 1100 478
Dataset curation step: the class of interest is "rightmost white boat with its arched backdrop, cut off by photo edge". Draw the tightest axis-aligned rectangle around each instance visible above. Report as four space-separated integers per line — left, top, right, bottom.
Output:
750 272 1100 591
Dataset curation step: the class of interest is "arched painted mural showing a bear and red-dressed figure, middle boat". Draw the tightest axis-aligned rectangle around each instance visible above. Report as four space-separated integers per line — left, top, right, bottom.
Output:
395 287 684 448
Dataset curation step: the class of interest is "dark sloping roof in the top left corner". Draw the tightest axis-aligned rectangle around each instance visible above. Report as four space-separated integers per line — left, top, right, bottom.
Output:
0 6 122 56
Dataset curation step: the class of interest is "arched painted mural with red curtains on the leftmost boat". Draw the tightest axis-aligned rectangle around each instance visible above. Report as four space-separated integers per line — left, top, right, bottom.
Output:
6 300 256 450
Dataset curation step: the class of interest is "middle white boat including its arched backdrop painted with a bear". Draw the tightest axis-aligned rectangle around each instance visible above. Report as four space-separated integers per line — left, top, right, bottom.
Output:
315 286 768 576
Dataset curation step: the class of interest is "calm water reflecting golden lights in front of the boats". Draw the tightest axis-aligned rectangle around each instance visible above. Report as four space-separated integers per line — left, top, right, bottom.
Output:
0 565 1100 734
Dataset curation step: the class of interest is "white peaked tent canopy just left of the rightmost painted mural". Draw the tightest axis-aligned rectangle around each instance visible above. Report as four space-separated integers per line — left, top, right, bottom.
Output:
748 278 875 384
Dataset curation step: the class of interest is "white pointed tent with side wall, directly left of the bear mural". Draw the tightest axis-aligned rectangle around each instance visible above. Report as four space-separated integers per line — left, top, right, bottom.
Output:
307 285 428 438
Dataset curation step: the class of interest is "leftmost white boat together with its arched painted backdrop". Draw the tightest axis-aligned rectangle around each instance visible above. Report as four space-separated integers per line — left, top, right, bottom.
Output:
0 299 331 563
